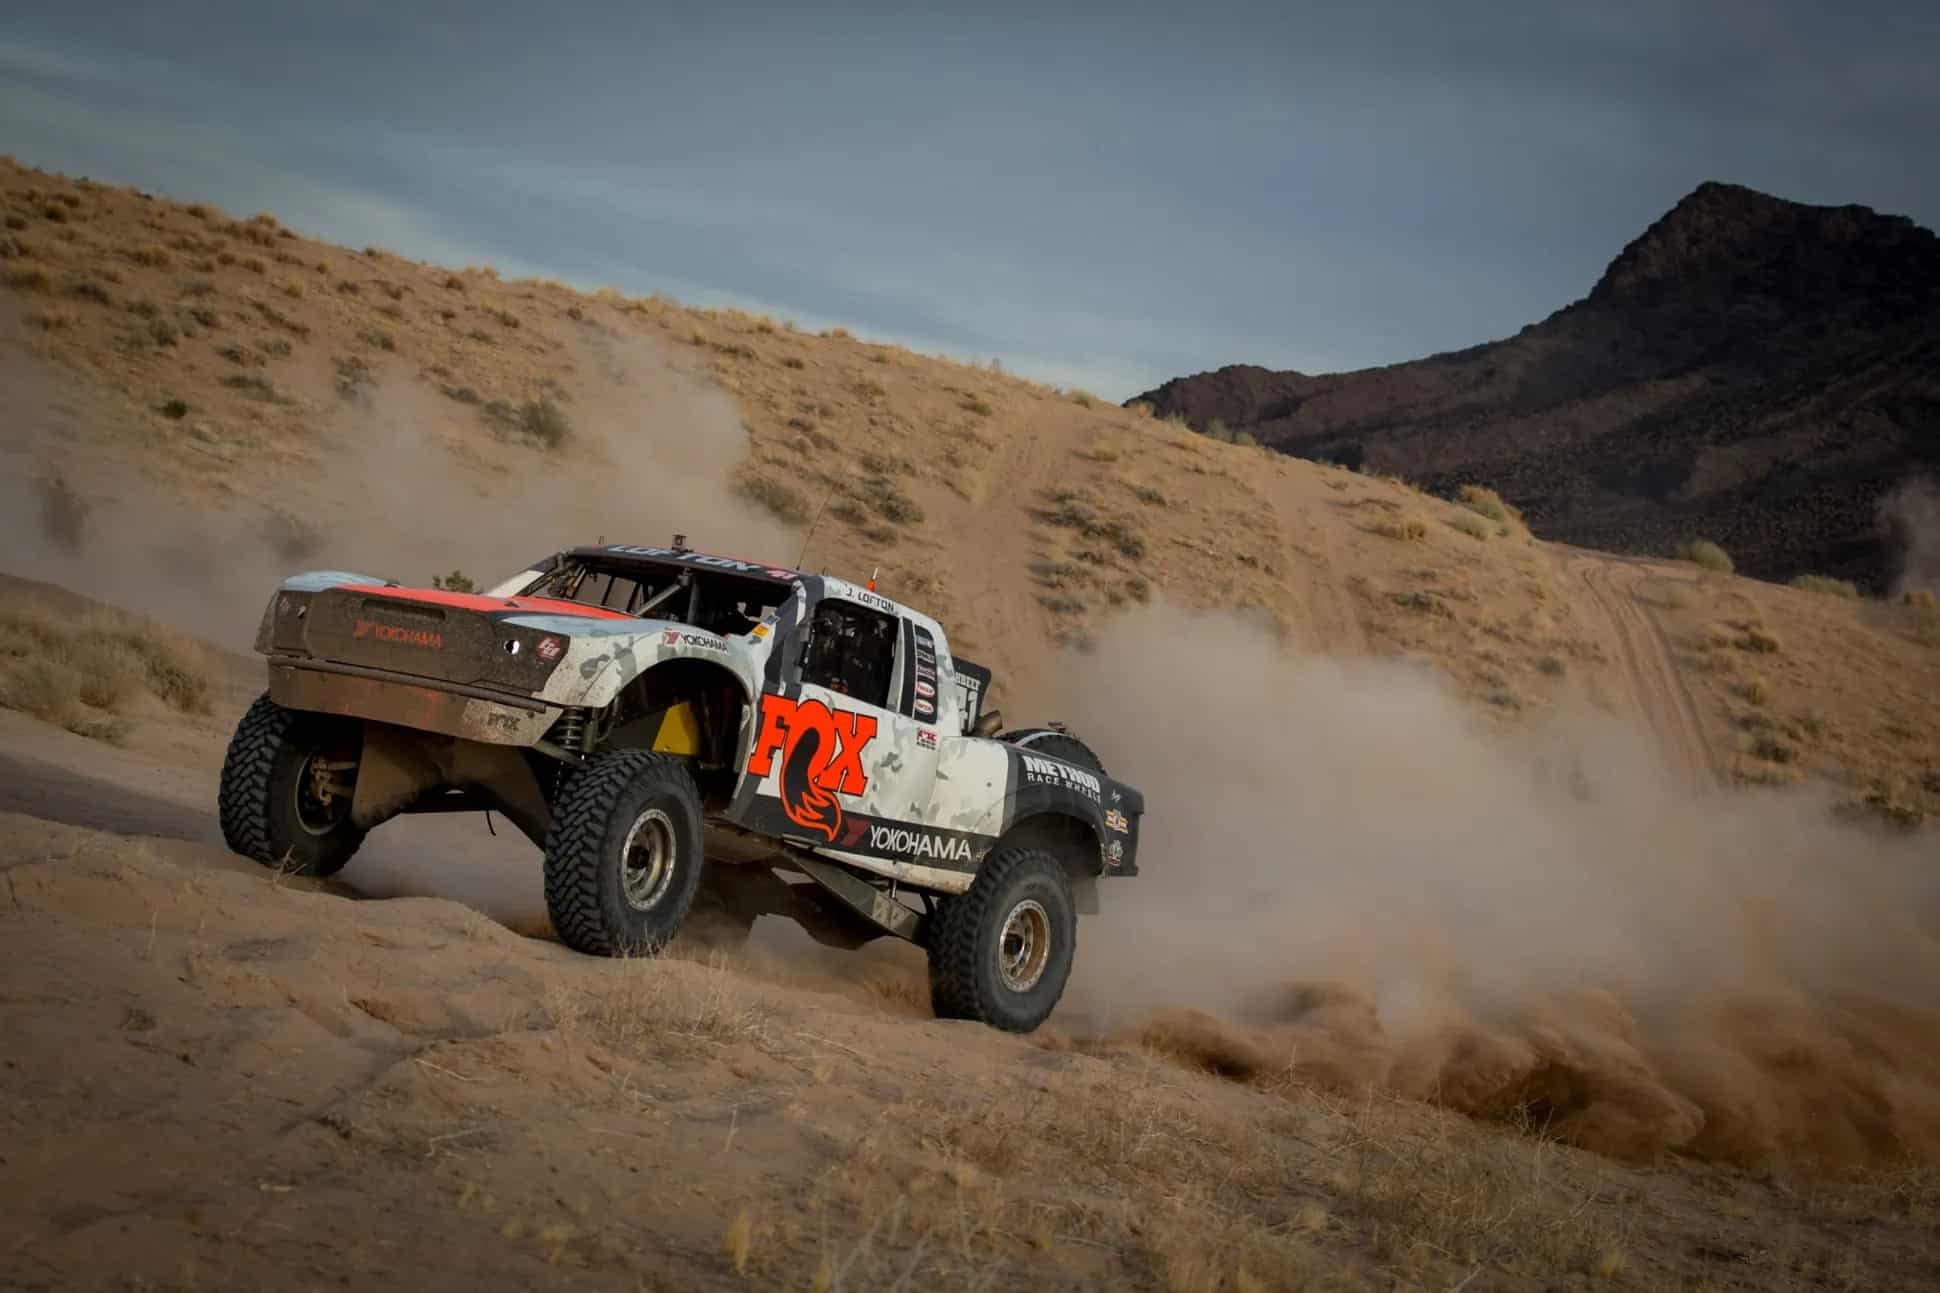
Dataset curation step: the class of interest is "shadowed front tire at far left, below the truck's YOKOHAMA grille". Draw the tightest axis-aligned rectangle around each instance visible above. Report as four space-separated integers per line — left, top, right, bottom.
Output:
215 693 365 876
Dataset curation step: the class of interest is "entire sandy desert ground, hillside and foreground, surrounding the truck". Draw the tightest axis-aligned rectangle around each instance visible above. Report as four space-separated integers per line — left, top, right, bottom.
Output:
0 153 1940 1293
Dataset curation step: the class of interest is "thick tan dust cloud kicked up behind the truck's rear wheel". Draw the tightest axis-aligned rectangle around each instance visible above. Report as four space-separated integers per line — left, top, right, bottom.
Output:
1020 608 1940 1165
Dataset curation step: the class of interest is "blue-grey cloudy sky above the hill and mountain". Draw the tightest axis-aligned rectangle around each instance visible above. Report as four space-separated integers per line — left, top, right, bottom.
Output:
0 0 1940 400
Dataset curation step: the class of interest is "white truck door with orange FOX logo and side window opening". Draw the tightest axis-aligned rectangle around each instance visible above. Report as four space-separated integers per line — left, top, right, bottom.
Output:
731 592 942 858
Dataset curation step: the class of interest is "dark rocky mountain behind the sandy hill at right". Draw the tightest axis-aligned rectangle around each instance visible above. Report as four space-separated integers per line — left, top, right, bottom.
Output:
1139 182 1940 592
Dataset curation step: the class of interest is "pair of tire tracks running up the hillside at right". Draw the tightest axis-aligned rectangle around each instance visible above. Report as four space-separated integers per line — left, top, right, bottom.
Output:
1564 553 1723 786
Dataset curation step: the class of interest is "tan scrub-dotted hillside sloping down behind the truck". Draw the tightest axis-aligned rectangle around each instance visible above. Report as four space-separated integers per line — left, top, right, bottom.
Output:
0 153 1940 813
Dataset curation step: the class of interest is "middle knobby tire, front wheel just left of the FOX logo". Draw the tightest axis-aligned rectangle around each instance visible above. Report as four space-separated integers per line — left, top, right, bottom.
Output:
545 749 706 957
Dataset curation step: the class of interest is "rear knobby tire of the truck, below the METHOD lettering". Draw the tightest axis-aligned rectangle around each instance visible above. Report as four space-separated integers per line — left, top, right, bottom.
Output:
923 845 1079 1033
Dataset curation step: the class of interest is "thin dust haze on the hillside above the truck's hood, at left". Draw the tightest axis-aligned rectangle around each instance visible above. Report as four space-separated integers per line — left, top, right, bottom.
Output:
0 326 801 648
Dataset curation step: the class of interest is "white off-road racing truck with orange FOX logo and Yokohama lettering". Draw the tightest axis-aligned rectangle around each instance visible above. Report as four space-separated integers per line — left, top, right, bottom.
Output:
219 536 1145 1031
